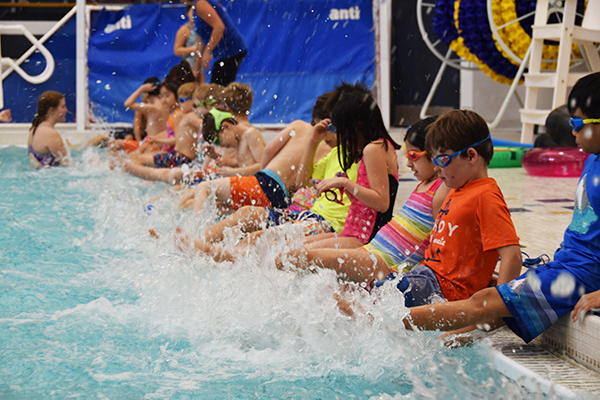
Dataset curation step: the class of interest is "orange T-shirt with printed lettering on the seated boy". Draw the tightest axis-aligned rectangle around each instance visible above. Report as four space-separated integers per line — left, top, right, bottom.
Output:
423 178 519 301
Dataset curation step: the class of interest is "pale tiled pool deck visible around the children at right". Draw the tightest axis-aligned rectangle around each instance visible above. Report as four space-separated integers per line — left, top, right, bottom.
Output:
392 129 600 398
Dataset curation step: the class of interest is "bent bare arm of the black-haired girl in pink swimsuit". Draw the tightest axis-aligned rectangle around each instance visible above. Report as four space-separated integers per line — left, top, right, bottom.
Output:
317 144 394 212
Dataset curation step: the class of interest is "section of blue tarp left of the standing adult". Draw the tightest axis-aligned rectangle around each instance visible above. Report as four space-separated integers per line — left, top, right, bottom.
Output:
88 4 185 122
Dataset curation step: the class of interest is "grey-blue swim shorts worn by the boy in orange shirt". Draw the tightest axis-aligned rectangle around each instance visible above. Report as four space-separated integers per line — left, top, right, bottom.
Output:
373 265 444 307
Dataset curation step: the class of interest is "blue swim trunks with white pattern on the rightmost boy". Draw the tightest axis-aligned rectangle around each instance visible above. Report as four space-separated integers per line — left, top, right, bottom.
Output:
496 262 585 343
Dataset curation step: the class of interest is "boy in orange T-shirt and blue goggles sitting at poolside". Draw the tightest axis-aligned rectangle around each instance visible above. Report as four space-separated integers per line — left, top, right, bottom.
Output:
360 110 522 308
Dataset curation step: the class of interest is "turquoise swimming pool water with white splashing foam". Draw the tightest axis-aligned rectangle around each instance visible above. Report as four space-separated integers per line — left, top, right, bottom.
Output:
0 147 543 400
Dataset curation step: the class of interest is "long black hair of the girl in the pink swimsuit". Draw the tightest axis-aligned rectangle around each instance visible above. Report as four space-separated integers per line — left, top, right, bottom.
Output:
325 83 401 171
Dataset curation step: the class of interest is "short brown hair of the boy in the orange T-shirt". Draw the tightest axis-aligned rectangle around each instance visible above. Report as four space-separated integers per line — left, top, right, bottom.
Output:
425 110 494 165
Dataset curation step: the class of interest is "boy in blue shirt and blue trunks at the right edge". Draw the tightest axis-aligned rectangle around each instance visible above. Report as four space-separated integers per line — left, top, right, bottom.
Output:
392 72 600 342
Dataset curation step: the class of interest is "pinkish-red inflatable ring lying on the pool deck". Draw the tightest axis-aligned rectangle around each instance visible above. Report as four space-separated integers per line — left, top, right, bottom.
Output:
521 147 589 178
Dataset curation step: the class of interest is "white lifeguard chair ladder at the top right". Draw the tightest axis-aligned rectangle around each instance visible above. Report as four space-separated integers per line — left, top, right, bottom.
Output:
520 0 600 143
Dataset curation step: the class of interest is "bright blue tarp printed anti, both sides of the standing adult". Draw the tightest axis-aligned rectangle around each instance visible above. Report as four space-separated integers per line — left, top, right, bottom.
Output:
88 0 375 123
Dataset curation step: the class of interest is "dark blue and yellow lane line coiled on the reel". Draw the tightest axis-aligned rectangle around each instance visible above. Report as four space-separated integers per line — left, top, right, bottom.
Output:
432 0 585 84
